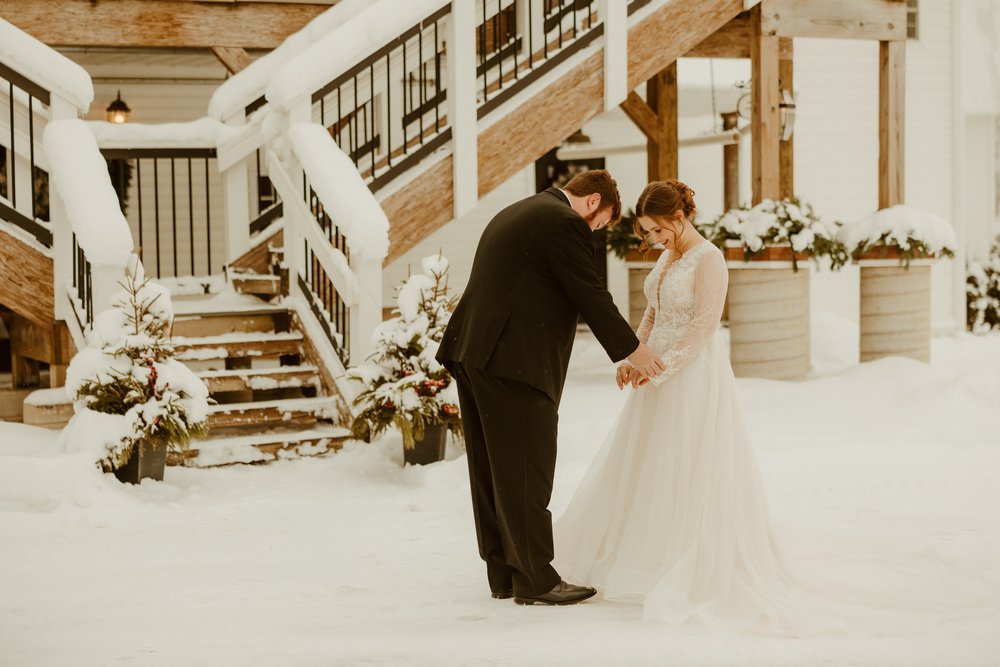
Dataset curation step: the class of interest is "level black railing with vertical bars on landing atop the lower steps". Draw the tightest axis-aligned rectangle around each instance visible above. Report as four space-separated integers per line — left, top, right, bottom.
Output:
101 148 225 278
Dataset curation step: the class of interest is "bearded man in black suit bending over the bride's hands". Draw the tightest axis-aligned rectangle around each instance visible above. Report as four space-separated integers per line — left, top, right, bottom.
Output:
437 169 663 605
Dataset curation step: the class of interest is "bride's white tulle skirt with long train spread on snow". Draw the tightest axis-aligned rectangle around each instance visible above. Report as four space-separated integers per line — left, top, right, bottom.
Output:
553 334 992 636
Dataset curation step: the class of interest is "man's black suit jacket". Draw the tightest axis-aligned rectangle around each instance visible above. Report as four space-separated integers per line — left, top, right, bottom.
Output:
437 188 639 403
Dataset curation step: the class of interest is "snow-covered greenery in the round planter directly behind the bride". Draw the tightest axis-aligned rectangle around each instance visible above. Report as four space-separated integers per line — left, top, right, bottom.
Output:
699 198 848 270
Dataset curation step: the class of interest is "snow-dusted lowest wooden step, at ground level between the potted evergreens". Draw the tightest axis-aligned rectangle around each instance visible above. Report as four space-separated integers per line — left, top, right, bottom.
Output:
167 424 351 468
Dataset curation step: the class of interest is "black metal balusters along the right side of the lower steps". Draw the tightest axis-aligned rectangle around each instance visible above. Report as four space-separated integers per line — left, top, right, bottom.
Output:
299 184 351 367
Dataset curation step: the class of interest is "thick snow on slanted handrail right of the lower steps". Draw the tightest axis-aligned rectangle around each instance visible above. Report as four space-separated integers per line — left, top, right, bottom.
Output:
288 123 389 261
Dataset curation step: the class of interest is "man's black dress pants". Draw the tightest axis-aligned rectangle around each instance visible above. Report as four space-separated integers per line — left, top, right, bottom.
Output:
453 362 560 596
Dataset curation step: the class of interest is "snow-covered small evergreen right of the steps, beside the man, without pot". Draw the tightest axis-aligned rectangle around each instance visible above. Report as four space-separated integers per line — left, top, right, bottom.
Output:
347 255 462 448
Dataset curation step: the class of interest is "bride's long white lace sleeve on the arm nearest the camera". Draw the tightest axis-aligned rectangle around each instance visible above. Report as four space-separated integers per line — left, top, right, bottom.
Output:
650 248 729 385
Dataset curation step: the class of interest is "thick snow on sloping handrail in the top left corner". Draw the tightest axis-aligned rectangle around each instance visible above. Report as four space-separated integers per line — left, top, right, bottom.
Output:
0 18 94 113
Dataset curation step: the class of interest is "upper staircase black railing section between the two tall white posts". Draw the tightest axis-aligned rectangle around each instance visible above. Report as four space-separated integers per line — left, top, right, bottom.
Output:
476 0 604 118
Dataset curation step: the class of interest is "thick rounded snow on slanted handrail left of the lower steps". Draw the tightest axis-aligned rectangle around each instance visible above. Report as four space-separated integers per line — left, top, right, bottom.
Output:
43 119 133 267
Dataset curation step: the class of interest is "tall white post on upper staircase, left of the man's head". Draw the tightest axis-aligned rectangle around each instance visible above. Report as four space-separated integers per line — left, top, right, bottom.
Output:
445 0 479 218
